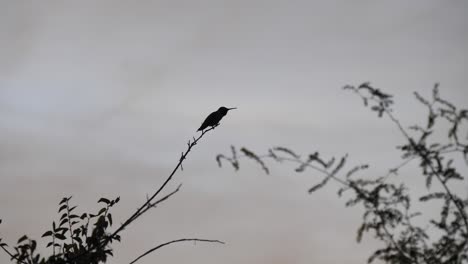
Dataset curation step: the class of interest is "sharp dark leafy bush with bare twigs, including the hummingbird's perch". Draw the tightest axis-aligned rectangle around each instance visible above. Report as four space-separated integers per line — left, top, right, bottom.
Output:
0 125 224 264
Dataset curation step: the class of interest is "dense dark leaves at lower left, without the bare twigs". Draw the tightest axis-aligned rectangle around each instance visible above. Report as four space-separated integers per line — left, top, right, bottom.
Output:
0 196 120 264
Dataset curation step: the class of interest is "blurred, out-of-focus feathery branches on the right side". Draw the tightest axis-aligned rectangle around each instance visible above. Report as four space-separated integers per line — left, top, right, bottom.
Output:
216 82 468 264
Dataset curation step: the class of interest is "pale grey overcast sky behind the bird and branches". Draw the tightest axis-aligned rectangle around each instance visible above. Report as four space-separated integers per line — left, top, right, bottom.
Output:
0 0 468 264
